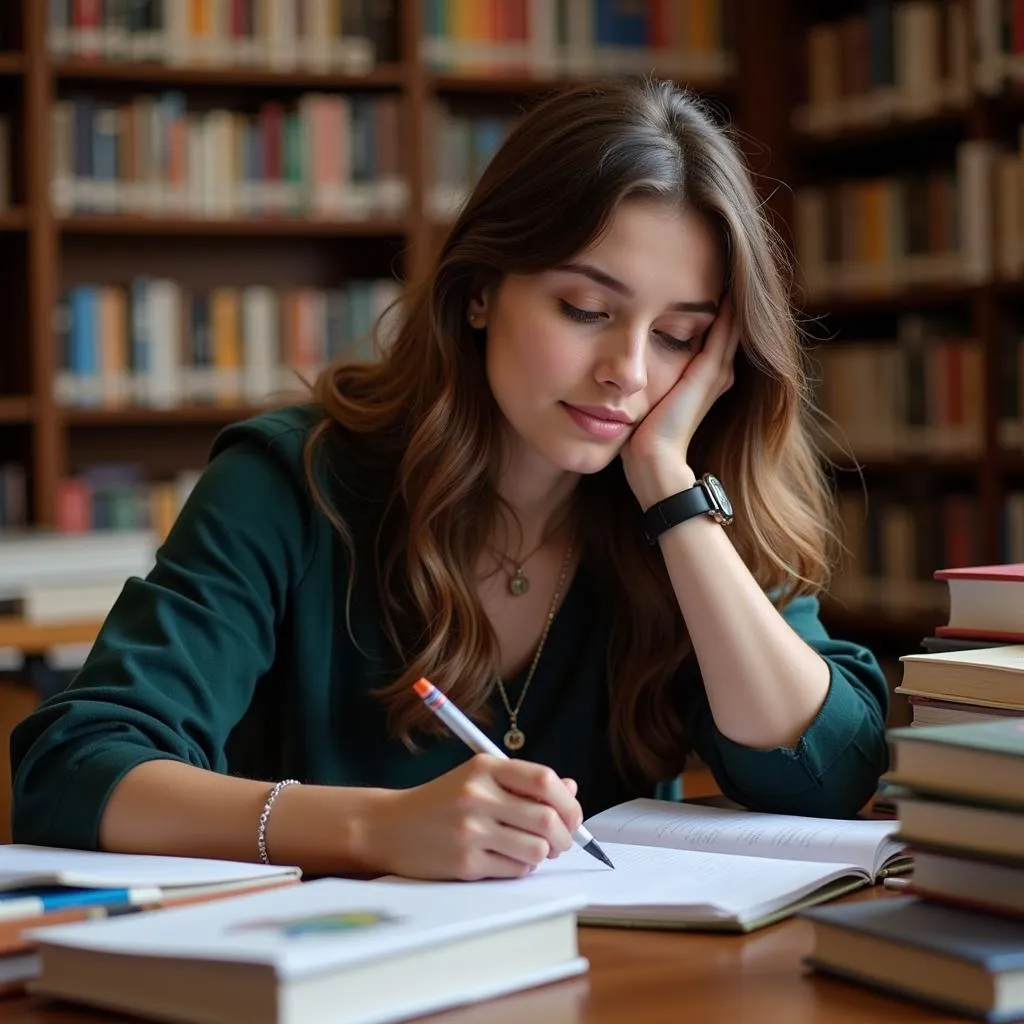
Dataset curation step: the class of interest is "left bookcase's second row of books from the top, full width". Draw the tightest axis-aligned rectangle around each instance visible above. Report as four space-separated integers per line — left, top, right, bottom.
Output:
51 90 409 219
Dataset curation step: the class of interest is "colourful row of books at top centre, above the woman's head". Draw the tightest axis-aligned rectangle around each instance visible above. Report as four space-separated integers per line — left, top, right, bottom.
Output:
421 0 735 81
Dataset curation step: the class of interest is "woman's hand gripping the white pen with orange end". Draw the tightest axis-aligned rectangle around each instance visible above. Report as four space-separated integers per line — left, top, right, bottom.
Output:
366 754 583 882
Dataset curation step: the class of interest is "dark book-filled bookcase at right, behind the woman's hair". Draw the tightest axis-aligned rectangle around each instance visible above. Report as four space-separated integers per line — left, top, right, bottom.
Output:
788 0 1024 653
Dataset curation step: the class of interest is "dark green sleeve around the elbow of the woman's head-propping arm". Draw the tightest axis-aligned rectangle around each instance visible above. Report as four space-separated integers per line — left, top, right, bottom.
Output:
680 597 889 817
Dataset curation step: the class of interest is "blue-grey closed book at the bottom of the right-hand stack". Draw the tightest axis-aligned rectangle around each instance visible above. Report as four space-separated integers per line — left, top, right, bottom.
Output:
803 896 1024 1022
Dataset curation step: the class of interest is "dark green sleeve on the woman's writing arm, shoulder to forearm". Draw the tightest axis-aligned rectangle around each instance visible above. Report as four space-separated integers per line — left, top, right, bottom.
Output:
10 437 310 849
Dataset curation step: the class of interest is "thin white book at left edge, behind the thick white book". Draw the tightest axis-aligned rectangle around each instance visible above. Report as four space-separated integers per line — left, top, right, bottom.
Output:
0 843 302 896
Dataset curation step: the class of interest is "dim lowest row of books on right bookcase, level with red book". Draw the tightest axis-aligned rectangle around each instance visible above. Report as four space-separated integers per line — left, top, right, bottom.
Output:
831 490 1024 614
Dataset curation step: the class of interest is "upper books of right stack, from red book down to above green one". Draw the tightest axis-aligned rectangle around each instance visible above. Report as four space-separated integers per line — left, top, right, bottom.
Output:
896 563 1024 726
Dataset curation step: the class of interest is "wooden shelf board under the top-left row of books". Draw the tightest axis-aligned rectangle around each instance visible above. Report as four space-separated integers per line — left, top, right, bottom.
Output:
50 58 408 90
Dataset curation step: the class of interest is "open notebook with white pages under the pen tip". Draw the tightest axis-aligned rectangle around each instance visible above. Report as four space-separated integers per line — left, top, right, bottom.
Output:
413 800 909 932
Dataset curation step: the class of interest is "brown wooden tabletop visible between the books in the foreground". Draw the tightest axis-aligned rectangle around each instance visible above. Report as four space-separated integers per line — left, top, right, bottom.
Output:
0 888 963 1024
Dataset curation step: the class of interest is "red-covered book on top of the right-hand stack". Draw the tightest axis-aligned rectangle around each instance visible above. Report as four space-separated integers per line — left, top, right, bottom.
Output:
934 562 1024 640
